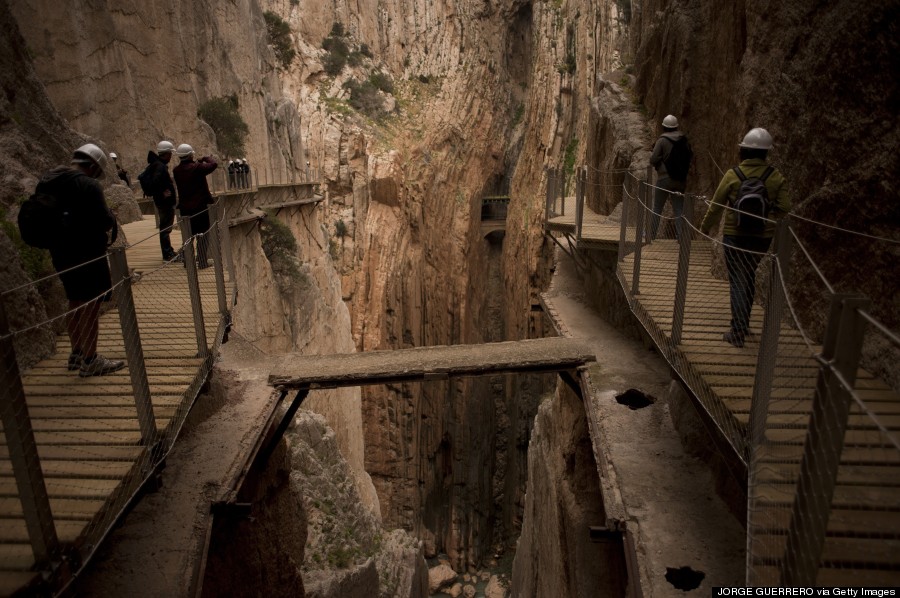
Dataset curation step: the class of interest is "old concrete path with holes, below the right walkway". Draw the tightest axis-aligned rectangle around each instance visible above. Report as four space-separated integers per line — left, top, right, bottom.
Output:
545 251 745 596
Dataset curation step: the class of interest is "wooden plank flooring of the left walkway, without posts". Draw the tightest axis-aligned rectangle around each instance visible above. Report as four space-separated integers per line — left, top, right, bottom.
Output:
0 216 220 595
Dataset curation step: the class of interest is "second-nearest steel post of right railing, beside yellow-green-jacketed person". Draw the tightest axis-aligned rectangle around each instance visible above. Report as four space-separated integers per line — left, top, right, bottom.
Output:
744 218 791 454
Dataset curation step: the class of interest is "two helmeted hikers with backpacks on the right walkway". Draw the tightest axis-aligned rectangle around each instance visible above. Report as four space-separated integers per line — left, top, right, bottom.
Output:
649 114 791 347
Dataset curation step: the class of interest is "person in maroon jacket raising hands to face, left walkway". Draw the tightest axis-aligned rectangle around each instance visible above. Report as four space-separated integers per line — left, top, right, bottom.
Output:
172 143 218 269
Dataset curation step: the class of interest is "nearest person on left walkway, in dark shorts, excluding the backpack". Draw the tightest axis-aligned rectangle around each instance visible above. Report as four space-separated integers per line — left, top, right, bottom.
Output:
35 143 125 378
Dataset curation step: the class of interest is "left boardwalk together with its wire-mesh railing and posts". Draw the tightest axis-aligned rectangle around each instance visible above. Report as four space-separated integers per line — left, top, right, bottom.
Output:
0 199 233 590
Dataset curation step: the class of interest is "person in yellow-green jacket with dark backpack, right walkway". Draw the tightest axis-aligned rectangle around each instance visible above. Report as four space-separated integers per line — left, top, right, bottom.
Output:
700 128 791 347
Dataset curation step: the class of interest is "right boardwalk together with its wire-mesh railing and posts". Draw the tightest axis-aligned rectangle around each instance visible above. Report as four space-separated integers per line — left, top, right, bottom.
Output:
545 170 900 586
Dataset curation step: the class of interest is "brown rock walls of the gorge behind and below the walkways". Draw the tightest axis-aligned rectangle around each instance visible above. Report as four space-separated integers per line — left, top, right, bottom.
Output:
0 0 900 598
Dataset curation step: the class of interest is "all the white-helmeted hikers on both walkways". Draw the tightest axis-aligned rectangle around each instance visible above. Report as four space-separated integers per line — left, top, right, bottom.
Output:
19 115 791 377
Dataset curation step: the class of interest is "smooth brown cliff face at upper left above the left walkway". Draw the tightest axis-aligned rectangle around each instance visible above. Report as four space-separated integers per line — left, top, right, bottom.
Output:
11 0 303 179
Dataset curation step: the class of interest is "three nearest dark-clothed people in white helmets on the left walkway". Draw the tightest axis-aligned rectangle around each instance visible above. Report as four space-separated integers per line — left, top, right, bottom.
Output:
19 140 217 377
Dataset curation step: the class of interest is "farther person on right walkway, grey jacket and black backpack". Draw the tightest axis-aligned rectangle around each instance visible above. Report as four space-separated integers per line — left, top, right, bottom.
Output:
649 114 694 241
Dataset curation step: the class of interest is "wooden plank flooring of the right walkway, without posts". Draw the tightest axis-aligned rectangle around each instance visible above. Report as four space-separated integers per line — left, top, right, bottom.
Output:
547 200 900 586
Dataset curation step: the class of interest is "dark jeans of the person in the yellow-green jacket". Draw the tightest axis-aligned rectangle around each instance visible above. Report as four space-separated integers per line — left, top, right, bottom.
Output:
722 235 772 338
